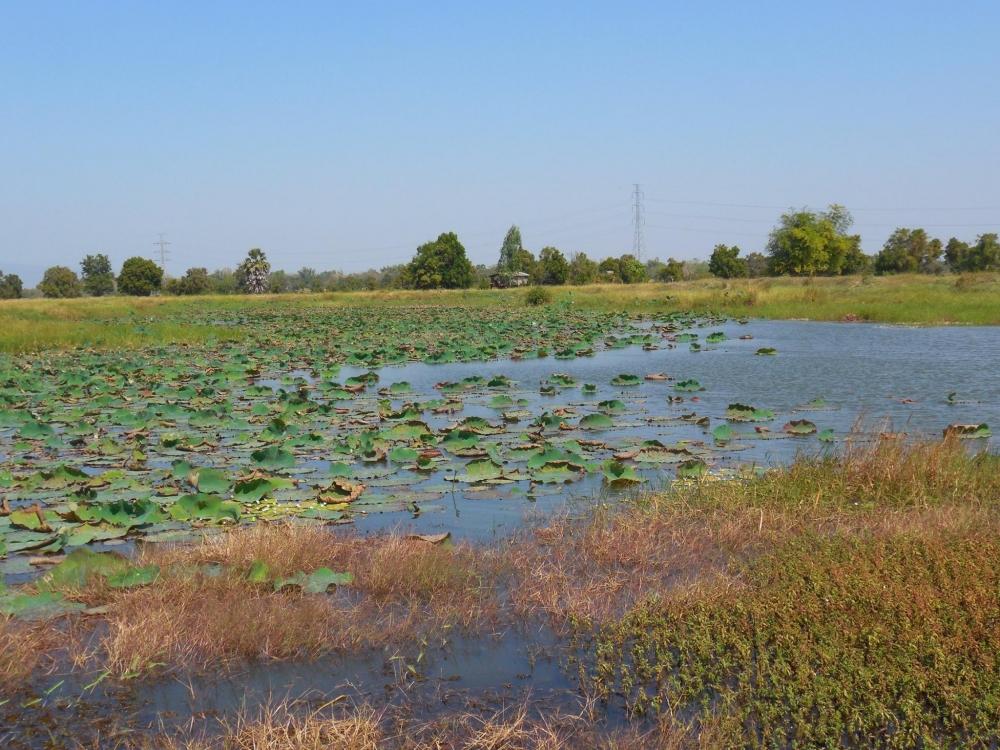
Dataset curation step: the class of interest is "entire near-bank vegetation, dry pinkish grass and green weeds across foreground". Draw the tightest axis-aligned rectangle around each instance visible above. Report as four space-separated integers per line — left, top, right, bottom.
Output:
0 438 1000 750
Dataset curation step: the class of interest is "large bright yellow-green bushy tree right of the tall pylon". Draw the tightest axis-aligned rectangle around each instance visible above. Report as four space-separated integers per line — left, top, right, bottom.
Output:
767 204 867 276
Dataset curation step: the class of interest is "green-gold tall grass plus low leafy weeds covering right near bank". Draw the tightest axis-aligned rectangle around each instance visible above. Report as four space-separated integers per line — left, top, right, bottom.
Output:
575 441 1000 748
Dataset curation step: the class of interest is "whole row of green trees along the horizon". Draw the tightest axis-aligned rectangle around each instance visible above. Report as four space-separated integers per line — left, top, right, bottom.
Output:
0 204 1000 299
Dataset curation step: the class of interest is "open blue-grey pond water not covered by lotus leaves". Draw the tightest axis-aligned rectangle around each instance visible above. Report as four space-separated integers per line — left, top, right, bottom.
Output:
298 321 1000 540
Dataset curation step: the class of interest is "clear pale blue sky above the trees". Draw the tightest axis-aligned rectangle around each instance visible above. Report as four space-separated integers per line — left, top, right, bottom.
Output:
0 0 1000 284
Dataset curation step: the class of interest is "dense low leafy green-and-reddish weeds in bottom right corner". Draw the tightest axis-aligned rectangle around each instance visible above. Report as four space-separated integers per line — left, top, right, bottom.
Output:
587 533 1000 747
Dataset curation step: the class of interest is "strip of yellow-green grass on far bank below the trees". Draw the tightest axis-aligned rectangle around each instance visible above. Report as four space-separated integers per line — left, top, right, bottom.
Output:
0 272 1000 353
